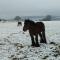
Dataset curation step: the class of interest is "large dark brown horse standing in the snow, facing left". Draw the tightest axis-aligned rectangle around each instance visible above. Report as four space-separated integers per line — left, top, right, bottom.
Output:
23 19 47 47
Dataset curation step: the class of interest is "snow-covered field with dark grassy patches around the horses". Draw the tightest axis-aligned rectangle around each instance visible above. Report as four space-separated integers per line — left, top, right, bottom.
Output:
0 21 60 60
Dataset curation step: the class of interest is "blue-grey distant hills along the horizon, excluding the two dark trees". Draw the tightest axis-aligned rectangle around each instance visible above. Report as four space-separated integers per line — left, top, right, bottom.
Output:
1 16 60 21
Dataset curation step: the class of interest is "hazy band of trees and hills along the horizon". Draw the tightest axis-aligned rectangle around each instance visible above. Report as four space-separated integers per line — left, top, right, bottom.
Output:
0 15 60 21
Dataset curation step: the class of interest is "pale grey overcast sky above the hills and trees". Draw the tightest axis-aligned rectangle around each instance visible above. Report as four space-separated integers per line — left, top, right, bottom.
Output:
0 0 60 17
